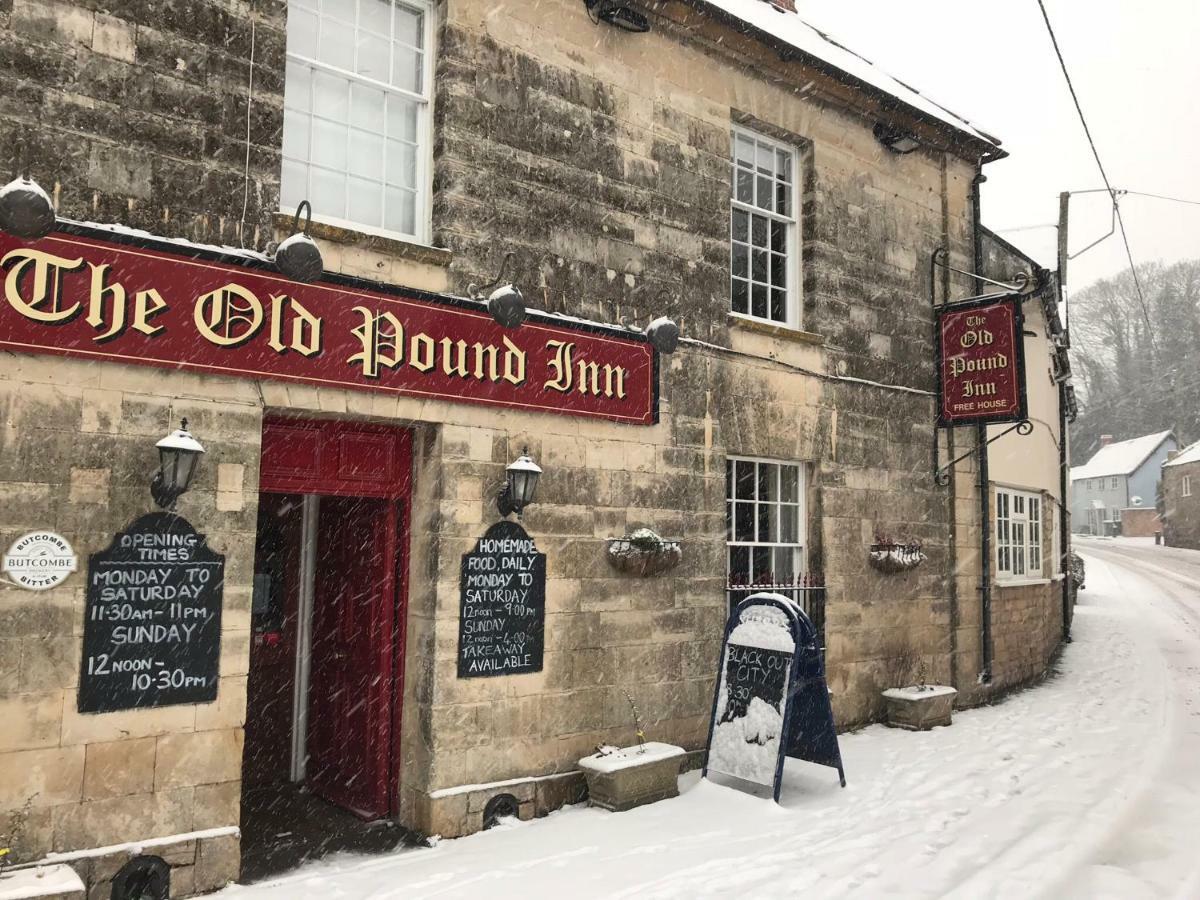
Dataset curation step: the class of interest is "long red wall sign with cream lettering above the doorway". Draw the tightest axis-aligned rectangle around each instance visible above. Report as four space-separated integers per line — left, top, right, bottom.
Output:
0 227 658 425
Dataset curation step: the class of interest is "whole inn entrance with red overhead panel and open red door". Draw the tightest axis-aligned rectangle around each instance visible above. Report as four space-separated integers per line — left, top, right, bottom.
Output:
241 421 410 881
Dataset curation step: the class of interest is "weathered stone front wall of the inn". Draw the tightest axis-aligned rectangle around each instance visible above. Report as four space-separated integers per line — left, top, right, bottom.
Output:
0 0 1061 896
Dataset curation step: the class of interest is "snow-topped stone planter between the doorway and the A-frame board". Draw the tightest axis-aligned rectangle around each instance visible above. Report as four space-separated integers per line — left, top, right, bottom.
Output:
580 742 686 812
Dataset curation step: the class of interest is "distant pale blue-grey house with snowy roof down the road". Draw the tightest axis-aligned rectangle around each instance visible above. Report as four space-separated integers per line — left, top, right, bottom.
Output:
1070 431 1180 534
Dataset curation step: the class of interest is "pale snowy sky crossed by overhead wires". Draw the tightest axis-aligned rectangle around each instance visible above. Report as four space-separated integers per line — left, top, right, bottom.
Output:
797 0 1200 296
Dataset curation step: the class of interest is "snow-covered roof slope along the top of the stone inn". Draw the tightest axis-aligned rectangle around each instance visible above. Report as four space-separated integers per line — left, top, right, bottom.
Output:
703 0 1003 155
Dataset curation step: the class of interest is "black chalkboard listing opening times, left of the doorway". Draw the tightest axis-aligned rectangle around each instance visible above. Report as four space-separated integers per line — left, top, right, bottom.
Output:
79 512 224 713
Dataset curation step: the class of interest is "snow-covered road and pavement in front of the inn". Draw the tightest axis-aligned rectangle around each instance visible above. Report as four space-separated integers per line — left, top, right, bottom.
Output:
221 541 1200 900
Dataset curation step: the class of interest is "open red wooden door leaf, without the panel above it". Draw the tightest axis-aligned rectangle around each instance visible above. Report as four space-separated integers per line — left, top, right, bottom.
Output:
307 497 396 818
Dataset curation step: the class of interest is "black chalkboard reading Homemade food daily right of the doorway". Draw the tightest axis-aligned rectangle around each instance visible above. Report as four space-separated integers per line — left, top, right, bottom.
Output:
458 521 546 678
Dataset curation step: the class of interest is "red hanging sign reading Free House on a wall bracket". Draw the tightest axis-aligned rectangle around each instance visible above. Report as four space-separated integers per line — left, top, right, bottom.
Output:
936 294 1026 428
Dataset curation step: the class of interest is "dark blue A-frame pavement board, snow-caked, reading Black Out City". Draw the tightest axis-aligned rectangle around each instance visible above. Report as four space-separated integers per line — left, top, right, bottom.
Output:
703 594 846 800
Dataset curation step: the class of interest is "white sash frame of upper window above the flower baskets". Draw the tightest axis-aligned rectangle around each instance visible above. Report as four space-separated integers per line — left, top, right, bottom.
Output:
726 125 803 330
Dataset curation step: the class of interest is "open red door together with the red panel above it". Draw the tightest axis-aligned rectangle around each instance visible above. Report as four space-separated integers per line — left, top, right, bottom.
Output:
259 419 412 818
